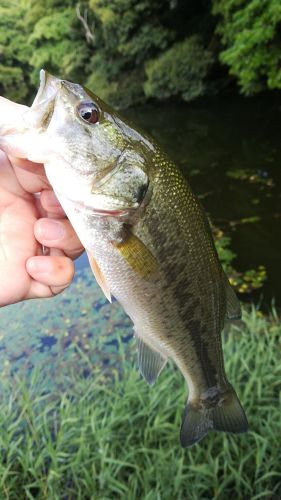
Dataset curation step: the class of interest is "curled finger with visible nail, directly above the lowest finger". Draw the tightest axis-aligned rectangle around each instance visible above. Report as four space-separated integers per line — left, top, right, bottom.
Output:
34 218 84 259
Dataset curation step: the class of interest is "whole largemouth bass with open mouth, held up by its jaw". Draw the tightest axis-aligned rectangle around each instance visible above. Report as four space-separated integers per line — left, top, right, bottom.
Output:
0 70 248 447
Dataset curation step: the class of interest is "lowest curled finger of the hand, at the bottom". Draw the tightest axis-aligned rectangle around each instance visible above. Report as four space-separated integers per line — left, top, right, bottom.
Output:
26 255 74 298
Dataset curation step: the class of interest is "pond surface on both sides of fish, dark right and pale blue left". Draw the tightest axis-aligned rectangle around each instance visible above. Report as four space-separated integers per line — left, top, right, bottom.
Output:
0 96 281 382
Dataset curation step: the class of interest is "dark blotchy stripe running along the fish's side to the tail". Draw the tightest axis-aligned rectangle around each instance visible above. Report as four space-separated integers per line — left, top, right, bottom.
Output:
143 163 225 387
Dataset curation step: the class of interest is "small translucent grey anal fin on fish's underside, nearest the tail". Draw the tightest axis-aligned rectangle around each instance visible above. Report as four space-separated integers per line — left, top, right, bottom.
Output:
137 338 167 385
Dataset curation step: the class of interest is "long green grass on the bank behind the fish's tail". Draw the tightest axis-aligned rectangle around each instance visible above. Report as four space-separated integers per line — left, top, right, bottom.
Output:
0 309 281 500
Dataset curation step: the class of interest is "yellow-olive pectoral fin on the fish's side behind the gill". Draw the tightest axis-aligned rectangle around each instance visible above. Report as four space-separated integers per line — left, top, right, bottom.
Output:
114 234 158 279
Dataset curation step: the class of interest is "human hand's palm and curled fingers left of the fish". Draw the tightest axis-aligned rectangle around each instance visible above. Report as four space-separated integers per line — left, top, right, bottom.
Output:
0 151 84 306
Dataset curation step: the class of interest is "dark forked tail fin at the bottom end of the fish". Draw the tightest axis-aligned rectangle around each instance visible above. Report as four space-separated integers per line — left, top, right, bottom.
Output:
180 388 248 448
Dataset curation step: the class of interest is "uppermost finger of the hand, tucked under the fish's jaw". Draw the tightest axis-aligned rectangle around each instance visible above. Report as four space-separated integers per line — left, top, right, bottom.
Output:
9 156 50 193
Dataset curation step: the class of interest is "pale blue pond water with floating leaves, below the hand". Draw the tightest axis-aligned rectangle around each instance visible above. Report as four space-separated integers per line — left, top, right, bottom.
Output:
0 266 134 393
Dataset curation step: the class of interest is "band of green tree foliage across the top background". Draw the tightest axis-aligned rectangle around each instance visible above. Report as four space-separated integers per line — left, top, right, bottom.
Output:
0 0 281 107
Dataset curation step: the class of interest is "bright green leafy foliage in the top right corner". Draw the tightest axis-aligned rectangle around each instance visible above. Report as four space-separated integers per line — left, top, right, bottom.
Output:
213 0 281 94
